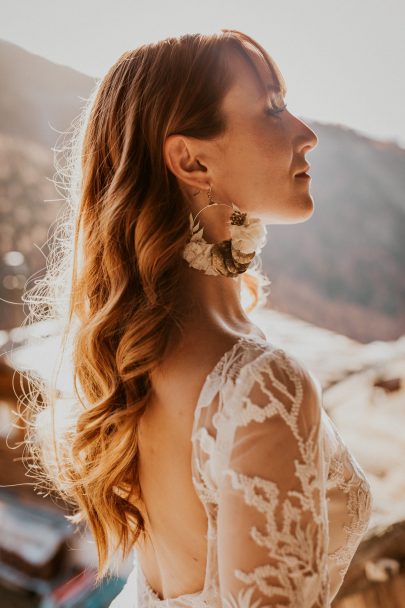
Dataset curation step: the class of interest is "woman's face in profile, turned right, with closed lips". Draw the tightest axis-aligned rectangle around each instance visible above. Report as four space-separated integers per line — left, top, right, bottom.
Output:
210 47 317 224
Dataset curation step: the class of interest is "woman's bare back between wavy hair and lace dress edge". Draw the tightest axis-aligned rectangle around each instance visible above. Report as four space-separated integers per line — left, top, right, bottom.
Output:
137 328 263 598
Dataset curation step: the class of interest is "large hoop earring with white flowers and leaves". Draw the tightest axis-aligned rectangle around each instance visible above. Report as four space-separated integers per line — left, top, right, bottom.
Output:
183 186 266 278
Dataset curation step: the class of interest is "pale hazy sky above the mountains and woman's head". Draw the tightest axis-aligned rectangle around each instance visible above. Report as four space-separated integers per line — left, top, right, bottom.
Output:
0 0 405 147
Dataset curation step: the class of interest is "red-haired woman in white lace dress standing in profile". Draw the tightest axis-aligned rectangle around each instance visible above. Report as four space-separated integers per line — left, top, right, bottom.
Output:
24 30 371 608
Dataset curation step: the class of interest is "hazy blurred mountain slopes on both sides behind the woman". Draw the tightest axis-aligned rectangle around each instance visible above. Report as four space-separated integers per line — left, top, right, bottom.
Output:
0 41 405 343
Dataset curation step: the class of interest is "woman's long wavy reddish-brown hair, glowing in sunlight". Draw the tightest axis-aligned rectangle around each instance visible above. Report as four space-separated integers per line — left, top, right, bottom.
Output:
22 29 284 580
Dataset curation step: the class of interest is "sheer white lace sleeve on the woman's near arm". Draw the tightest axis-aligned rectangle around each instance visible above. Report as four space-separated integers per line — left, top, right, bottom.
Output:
217 349 330 608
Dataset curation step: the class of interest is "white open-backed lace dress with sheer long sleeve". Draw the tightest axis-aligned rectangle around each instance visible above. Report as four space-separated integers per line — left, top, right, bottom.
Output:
110 337 372 608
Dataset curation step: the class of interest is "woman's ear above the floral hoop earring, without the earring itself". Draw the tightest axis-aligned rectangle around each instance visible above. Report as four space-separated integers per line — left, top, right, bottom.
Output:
163 134 209 189
